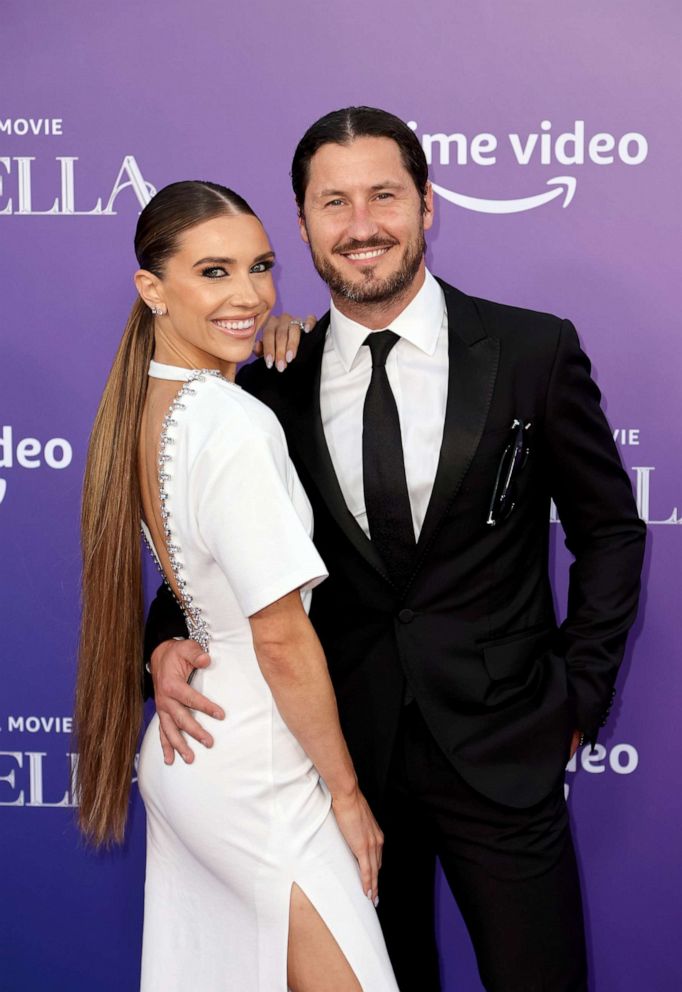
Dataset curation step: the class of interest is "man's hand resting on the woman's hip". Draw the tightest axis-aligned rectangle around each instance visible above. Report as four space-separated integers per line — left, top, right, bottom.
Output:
149 641 225 765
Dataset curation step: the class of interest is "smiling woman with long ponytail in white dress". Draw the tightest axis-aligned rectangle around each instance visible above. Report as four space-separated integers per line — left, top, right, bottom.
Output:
76 182 397 992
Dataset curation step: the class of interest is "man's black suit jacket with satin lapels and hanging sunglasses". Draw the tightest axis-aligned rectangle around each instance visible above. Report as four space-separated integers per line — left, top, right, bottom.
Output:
147 282 645 808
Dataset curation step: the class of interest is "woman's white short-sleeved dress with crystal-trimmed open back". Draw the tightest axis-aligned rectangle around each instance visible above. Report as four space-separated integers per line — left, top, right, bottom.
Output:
138 362 397 992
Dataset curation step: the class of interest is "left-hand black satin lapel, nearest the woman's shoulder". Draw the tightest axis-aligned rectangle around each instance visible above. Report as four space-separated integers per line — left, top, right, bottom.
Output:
288 315 390 582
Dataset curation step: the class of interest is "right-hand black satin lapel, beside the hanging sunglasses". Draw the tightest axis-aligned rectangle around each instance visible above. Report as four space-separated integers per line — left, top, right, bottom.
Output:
415 280 500 571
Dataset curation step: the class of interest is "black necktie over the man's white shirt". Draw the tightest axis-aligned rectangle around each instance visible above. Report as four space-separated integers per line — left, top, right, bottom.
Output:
362 331 415 586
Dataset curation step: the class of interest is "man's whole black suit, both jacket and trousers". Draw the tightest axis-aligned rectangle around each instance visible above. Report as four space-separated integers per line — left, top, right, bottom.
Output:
141 282 646 992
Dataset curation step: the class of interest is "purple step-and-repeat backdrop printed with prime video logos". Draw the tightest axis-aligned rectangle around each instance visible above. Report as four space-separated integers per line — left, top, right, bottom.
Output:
0 0 682 992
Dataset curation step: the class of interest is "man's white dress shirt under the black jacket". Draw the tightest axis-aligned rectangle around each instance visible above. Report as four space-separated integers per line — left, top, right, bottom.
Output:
320 270 448 539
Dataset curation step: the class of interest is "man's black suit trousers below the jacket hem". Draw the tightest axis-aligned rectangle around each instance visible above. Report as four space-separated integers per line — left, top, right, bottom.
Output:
378 703 587 992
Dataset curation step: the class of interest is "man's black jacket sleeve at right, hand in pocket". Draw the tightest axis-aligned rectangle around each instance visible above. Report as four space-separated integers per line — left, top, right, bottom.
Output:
545 321 646 743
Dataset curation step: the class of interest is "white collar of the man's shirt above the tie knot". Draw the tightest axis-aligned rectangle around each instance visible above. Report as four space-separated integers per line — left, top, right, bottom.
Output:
329 269 445 372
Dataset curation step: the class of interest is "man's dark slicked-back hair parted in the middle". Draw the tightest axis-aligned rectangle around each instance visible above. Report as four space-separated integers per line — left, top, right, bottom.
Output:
291 107 429 214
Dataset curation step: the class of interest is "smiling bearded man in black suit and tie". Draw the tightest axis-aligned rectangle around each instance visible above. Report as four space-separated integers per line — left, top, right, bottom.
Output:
148 108 644 992
